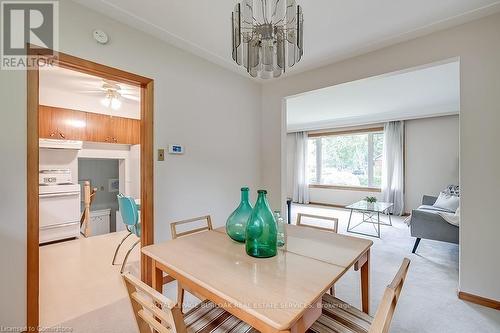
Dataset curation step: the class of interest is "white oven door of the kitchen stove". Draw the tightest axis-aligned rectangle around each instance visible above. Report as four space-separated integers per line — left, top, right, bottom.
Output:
39 191 80 228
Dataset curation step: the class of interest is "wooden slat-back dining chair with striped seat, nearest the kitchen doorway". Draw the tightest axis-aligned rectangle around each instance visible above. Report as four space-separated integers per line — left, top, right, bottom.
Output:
122 273 258 333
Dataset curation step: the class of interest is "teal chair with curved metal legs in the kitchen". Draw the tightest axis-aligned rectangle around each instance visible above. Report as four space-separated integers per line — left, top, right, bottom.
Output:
112 193 141 273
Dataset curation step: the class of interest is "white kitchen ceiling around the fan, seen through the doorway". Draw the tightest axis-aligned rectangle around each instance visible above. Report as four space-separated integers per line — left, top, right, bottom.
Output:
39 66 141 119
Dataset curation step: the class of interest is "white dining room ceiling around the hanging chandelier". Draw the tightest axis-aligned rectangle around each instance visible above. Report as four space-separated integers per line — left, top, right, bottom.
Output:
76 0 500 75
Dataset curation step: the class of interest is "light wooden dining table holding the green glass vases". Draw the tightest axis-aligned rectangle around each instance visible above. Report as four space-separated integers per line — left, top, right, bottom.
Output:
142 225 373 333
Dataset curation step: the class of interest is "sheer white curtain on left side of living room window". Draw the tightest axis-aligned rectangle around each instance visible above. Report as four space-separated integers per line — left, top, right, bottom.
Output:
292 132 309 204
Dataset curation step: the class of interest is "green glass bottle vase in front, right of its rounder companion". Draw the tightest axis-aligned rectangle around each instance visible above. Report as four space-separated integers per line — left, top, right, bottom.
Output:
245 190 278 258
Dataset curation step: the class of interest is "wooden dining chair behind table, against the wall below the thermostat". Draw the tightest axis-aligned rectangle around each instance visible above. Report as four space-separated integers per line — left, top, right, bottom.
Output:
170 215 213 312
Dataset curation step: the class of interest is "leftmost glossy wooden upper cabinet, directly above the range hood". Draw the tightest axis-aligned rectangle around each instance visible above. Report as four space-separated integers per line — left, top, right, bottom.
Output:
38 105 86 141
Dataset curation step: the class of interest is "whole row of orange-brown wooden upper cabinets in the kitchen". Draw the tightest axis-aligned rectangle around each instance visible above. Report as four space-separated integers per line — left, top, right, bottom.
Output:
38 105 141 144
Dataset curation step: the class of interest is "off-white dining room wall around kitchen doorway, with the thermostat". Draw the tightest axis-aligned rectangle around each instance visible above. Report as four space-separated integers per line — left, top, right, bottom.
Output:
0 1 261 326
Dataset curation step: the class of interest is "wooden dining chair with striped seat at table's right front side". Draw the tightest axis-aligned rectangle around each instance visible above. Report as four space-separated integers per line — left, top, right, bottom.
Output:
307 258 410 333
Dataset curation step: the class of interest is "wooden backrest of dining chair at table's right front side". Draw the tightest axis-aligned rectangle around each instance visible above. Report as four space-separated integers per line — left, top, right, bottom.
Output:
368 258 410 333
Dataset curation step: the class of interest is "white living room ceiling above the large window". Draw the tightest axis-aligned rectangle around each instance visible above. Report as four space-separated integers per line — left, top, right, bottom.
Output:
287 62 460 131
